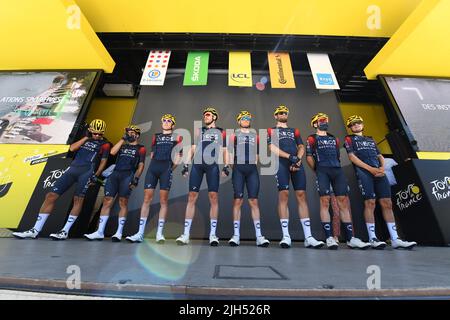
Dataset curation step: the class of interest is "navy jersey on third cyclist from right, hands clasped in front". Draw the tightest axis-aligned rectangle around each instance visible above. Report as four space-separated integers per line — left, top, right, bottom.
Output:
267 127 303 156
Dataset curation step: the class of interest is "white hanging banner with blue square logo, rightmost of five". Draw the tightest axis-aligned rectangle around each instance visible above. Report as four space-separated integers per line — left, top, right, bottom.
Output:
307 53 339 89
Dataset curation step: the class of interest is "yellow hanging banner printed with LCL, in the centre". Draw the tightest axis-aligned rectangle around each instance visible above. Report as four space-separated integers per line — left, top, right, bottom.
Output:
228 52 253 87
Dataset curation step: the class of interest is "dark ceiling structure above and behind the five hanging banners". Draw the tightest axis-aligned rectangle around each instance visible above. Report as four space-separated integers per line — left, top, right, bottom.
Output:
98 33 389 102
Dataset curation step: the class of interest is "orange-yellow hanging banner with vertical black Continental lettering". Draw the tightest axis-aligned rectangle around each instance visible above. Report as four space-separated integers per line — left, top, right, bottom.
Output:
268 52 295 89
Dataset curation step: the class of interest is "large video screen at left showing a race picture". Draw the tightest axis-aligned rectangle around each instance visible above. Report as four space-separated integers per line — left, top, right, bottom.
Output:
0 70 97 145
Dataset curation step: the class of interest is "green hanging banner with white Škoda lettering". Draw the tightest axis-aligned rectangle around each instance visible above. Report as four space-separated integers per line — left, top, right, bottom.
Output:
183 51 209 86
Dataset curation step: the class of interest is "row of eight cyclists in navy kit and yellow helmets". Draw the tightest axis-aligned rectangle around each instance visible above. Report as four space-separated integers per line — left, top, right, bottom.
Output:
13 106 416 249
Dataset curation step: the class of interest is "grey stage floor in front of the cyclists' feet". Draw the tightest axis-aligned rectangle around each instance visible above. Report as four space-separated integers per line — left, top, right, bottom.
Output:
0 238 450 299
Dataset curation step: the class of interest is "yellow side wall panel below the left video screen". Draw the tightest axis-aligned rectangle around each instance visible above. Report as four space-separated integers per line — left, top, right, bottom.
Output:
0 144 69 228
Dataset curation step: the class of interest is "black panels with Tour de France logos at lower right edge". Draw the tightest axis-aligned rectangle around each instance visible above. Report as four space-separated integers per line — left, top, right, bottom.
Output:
392 159 450 246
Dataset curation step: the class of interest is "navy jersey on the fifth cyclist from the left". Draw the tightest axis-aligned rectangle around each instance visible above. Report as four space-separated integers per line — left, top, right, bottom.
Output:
230 129 259 164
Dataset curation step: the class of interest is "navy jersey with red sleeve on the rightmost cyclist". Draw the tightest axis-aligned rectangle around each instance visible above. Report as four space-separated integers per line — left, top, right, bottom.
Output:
344 134 381 168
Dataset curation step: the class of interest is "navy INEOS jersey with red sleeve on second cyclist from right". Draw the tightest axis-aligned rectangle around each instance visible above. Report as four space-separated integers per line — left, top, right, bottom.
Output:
306 133 341 168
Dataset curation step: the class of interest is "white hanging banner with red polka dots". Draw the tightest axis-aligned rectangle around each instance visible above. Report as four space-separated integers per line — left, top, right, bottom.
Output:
141 50 171 86
